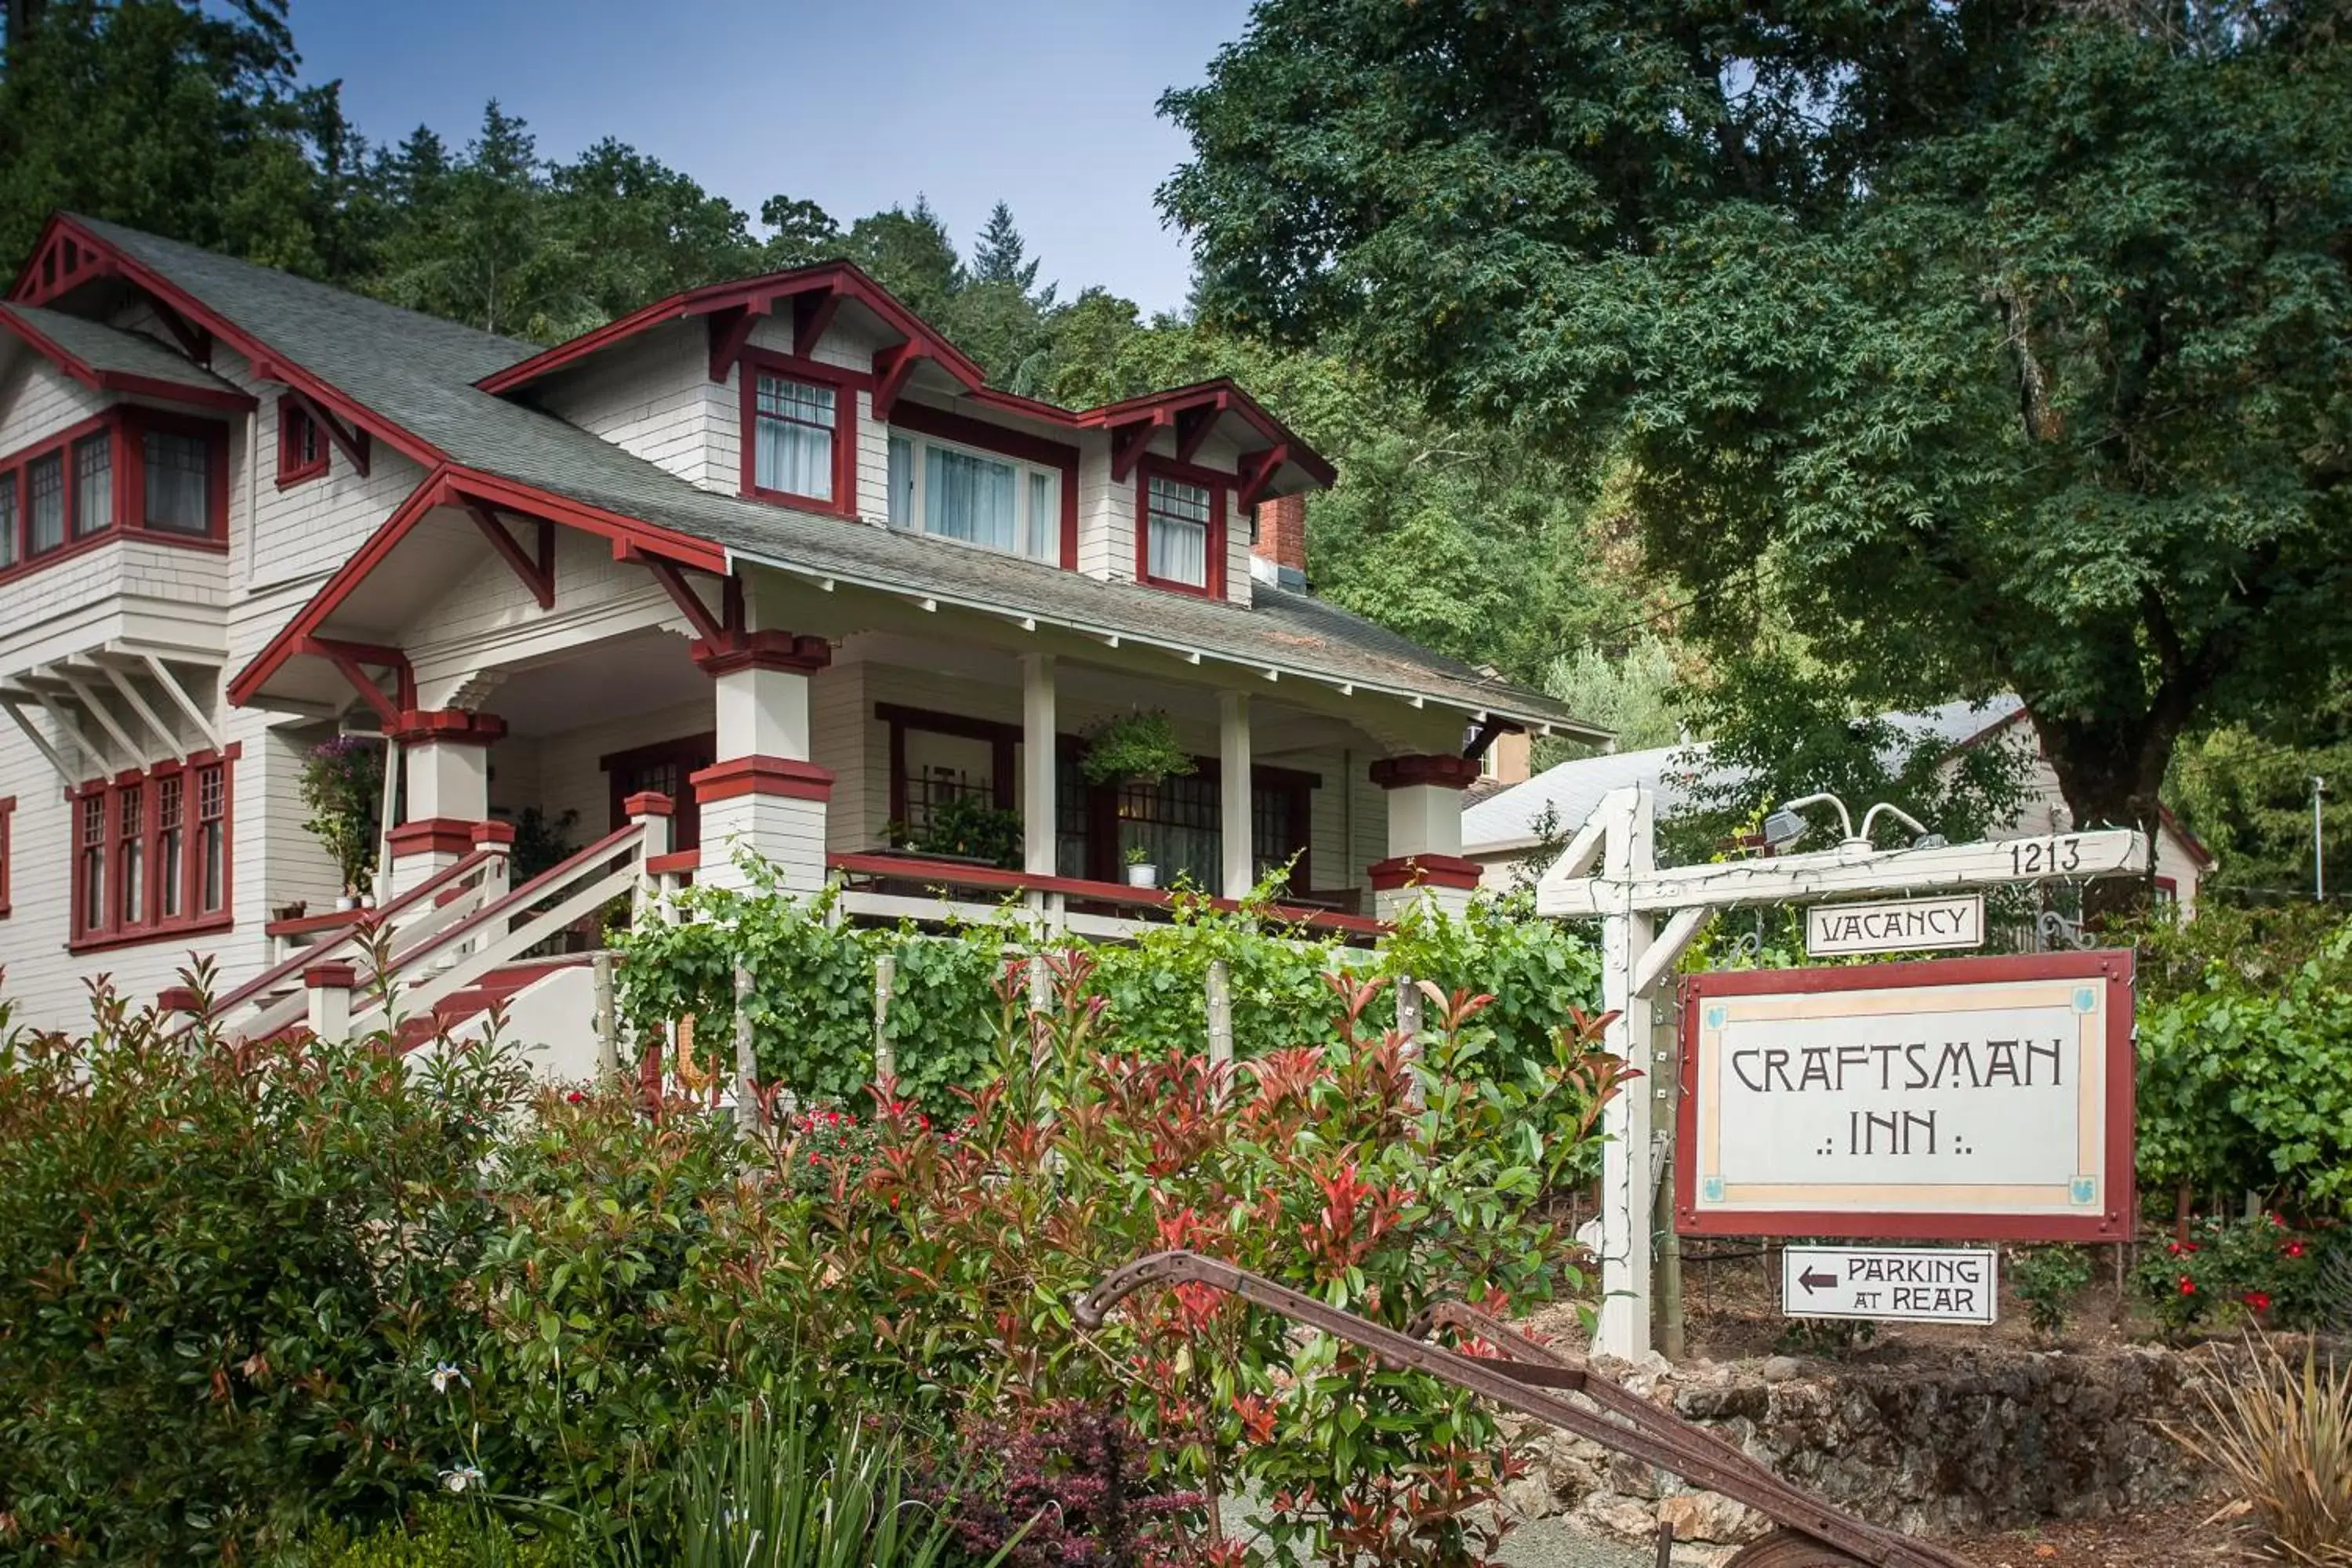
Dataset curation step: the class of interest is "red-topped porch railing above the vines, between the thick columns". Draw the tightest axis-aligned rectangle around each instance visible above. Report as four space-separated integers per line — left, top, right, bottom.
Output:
826 853 1388 940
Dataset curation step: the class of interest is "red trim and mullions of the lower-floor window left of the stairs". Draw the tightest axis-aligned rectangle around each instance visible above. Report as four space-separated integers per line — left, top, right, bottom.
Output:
66 746 245 952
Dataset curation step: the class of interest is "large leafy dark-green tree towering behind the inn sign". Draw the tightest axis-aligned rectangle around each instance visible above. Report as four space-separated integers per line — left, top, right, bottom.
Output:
1162 0 2352 846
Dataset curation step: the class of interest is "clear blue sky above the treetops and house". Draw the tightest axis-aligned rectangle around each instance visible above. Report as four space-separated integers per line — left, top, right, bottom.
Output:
292 0 1249 310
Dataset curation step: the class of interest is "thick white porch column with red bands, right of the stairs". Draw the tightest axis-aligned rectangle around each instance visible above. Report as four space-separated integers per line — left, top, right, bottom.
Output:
689 633 833 893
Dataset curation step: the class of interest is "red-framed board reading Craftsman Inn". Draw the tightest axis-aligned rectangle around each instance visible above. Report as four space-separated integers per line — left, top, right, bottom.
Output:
1675 952 2133 1241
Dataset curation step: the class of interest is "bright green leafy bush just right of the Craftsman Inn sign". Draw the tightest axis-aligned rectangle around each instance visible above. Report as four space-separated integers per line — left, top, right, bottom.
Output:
2138 919 2352 1213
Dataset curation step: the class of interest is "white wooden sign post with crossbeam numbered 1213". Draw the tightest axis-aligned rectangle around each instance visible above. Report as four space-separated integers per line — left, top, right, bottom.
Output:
1536 785 2147 1359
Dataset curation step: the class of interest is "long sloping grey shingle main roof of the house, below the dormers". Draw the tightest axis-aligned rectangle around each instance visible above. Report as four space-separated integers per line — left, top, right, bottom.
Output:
75 219 1588 729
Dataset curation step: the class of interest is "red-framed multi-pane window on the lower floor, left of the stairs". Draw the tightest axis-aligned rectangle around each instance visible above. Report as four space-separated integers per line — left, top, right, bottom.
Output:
68 748 238 949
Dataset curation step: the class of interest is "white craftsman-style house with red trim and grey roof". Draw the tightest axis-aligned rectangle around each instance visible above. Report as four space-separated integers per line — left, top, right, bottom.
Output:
0 214 1590 1044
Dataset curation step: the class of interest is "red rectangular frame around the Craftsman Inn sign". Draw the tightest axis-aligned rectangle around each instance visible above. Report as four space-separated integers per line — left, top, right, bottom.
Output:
1675 947 2138 1241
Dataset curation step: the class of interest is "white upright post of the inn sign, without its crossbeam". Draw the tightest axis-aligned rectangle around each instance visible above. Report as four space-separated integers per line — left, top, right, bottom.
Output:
1592 789 1658 1361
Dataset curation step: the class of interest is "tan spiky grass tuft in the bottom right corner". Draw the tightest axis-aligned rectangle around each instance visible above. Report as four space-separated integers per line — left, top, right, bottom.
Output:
2164 1340 2352 1568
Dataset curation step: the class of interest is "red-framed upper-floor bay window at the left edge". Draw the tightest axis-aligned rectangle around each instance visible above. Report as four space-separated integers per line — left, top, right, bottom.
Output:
0 407 228 574
